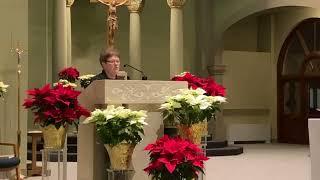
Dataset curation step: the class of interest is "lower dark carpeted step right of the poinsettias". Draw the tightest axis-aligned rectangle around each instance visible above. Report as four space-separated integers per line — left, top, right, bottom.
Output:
207 146 243 156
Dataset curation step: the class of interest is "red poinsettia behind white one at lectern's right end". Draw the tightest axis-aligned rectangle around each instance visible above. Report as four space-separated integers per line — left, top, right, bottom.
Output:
172 72 226 97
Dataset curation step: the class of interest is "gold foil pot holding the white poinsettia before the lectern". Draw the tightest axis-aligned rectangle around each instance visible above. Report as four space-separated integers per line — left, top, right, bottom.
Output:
104 143 135 170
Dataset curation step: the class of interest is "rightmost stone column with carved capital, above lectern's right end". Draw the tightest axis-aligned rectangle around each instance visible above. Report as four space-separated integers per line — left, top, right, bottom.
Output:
167 0 186 77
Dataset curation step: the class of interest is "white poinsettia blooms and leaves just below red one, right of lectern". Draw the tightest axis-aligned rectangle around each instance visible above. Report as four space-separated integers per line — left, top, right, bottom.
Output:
160 88 226 126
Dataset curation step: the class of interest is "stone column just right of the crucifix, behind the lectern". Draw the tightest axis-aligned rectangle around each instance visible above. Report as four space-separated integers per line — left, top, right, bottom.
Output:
127 0 145 79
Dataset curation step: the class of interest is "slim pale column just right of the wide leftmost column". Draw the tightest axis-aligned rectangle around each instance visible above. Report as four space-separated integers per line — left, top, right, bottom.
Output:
66 0 74 66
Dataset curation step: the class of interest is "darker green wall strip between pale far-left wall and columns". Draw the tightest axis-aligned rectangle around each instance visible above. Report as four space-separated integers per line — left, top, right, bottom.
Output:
28 0 52 129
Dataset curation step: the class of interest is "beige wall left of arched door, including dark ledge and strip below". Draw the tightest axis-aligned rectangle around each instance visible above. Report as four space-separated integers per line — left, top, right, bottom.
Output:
221 51 272 139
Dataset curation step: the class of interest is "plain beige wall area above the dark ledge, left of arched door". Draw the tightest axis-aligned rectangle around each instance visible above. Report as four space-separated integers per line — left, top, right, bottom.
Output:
223 51 271 109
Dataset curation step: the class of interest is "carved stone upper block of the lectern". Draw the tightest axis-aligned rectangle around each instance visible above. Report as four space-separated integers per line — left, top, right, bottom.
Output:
86 80 188 104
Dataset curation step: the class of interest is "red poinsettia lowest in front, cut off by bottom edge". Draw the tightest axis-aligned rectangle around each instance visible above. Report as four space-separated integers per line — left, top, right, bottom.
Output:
144 135 208 180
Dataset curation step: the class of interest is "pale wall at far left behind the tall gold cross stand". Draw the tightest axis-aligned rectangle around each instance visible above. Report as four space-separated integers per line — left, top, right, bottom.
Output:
0 0 28 168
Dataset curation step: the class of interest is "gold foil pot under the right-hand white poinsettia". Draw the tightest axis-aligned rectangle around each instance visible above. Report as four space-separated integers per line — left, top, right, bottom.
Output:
177 122 208 144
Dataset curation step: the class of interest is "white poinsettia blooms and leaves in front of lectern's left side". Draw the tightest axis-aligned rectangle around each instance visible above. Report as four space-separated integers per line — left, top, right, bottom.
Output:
83 105 147 146
